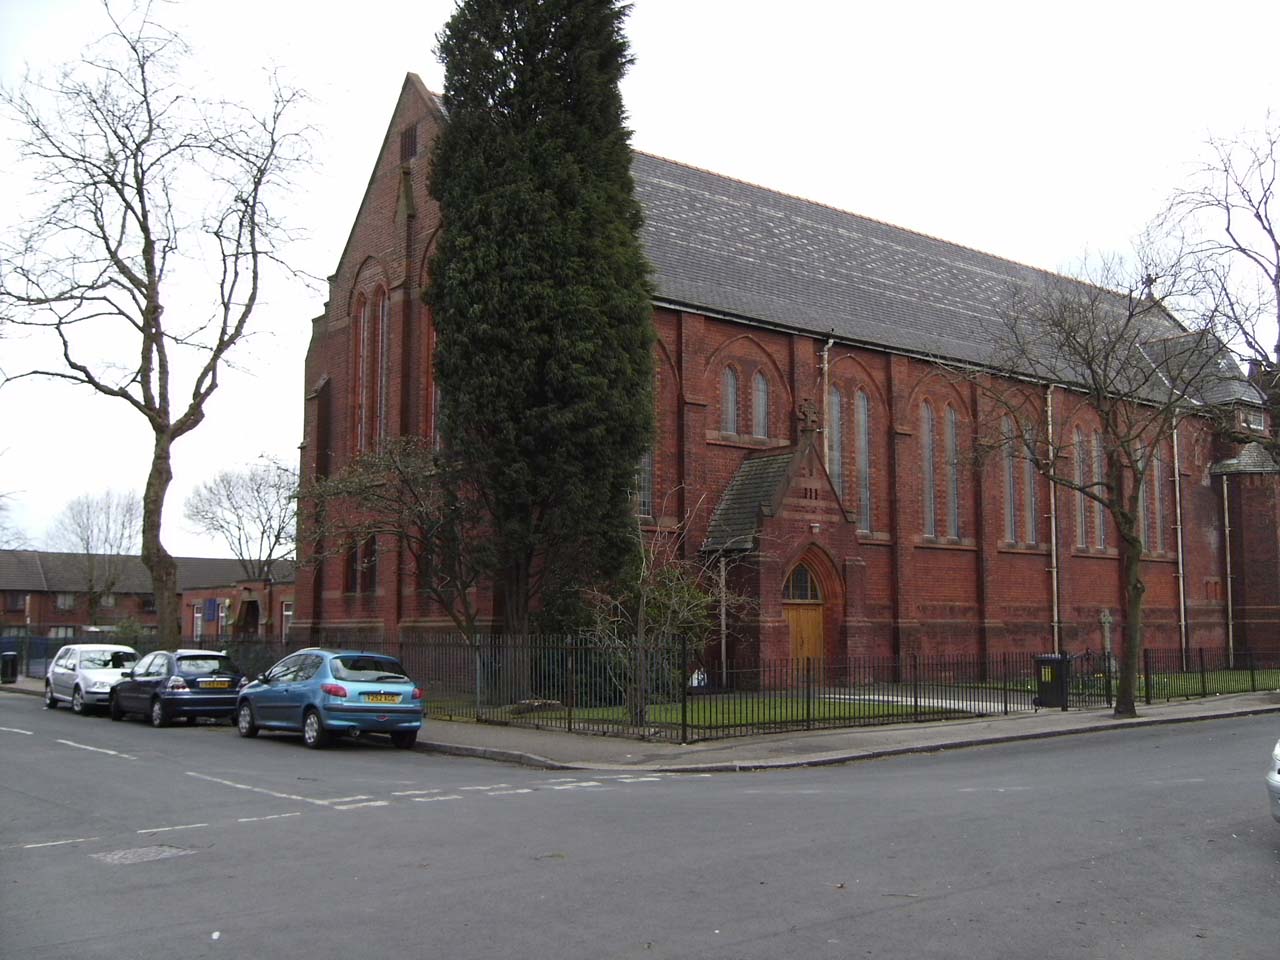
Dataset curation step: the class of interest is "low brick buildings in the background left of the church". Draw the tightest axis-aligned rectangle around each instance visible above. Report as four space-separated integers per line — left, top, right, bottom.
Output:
0 550 293 639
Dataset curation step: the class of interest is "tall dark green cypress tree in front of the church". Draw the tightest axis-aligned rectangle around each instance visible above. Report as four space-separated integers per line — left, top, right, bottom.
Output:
426 0 653 634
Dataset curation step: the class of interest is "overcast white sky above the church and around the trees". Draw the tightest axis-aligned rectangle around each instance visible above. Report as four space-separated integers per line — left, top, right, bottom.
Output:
0 0 1280 556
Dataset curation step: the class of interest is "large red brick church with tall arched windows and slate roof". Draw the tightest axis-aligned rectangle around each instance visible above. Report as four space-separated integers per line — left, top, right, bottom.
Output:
294 74 1280 657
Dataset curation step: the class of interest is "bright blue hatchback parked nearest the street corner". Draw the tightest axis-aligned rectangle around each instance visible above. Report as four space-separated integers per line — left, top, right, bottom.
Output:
236 648 422 750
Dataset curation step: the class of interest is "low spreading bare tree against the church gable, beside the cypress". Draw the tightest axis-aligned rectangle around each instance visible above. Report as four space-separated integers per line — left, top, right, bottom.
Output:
298 436 494 641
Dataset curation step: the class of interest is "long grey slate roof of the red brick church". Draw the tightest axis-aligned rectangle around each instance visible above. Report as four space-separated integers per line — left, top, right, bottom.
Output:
631 152 1260 402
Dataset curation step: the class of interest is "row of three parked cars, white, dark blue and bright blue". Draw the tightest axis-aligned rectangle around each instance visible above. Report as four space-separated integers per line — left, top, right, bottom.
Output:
45 644 422 750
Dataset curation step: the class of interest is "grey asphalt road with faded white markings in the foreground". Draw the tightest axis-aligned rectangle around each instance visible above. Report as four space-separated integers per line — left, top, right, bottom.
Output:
0 696 1280 960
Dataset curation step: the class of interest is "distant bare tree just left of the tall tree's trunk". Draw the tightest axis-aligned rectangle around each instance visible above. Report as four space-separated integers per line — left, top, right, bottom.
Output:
49 490 142 623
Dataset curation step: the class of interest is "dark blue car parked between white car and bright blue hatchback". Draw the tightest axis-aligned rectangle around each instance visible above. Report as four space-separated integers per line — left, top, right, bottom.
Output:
108 650 244 727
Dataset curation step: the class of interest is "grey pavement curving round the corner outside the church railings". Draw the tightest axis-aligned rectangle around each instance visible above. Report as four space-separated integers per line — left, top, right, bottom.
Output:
10 677 1280 773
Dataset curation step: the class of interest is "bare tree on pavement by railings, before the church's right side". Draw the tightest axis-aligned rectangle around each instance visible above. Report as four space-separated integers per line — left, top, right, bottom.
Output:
974 261 1239 717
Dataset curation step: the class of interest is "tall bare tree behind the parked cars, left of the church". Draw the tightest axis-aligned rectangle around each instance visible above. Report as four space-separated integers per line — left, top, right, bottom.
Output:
0 3 305 640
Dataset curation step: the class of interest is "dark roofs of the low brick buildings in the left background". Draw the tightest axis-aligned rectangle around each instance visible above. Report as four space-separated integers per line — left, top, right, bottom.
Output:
0 550 294 594
